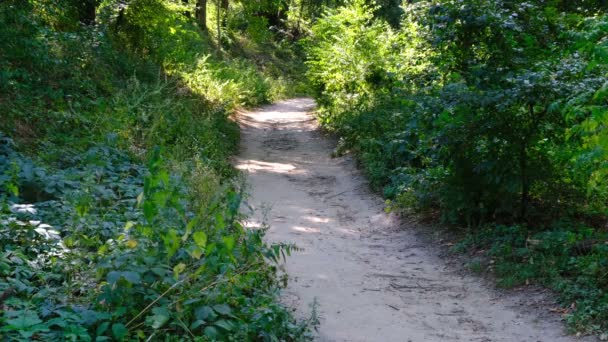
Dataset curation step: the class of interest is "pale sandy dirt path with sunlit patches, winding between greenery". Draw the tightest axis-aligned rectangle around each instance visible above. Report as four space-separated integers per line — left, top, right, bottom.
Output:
236 99 574 342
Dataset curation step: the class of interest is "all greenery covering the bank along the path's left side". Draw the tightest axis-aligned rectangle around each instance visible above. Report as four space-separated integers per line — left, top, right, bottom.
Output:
0 0 309 341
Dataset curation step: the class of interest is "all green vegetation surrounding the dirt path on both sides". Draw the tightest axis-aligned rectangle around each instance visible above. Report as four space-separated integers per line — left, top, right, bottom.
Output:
0 0 608 341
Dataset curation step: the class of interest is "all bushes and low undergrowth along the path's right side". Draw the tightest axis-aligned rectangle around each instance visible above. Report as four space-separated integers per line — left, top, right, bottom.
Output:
306 0 608 332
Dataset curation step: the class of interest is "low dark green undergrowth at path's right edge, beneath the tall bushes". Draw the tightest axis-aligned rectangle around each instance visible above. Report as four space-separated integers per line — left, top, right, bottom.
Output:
452 222 608 336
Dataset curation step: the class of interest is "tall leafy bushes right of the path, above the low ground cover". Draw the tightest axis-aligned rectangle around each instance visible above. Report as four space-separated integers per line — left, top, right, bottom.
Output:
307 1 606 225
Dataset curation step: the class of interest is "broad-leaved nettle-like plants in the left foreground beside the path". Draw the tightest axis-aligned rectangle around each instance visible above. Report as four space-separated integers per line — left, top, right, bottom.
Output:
0 139 308 341
